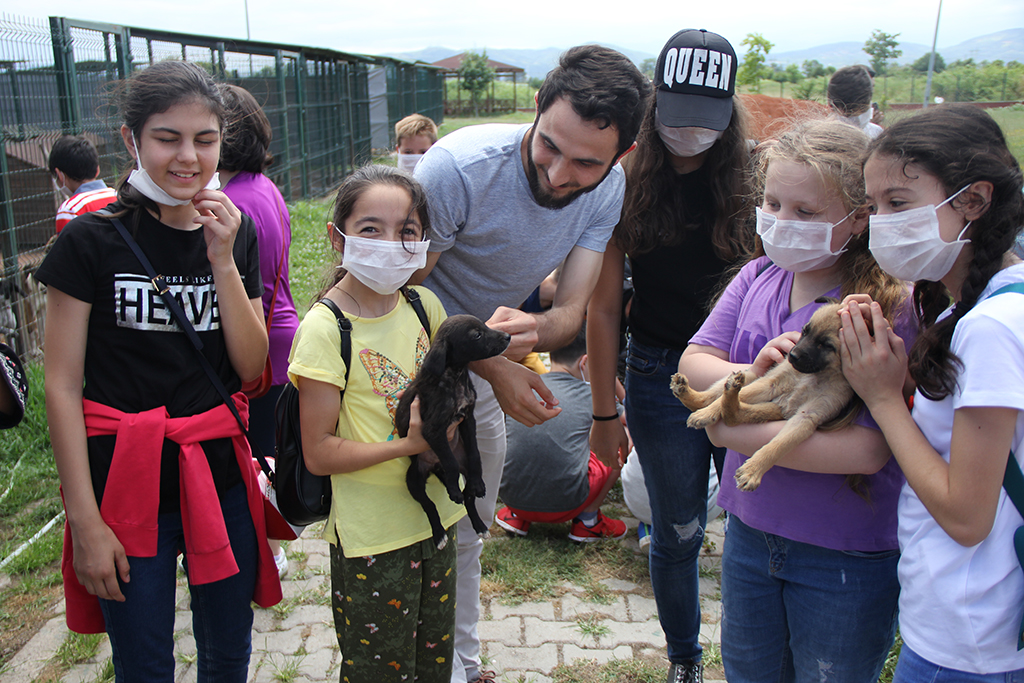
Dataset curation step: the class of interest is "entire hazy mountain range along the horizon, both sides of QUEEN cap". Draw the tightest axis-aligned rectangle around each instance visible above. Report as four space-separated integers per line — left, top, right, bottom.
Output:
388 29 1024 78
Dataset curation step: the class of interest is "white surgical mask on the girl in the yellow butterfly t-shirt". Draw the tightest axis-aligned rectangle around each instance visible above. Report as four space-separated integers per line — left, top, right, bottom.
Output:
334 231 430 296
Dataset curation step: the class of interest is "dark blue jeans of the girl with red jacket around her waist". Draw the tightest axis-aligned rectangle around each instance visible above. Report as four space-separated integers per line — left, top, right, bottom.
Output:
99 484 258 683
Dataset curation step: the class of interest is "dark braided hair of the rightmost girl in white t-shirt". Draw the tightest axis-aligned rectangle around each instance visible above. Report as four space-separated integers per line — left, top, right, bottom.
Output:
868 104 1024 400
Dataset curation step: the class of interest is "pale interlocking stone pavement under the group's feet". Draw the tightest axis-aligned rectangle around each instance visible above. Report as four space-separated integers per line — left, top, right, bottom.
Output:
0 518 723 683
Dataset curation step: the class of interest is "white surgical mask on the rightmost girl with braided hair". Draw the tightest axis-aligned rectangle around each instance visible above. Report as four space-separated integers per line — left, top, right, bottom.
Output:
867 185 971 282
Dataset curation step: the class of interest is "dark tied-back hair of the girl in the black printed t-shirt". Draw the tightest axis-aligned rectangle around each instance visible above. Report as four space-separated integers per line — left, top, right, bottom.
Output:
115 61 224 228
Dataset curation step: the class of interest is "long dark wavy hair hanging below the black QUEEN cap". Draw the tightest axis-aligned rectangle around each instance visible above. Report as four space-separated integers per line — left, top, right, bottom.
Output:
614 96 753 261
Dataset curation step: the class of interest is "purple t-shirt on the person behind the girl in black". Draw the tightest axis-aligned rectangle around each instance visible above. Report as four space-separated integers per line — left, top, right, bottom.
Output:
224 171 299 386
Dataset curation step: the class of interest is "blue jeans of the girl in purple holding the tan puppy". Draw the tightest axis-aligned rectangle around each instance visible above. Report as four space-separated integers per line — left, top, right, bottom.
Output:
722 515 899 683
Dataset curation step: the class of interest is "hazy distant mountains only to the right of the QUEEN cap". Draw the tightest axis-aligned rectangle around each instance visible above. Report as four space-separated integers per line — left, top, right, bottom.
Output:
768 29 1024 67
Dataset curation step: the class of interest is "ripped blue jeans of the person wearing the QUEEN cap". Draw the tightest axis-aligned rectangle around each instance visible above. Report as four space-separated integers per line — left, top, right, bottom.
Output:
626 340 713 663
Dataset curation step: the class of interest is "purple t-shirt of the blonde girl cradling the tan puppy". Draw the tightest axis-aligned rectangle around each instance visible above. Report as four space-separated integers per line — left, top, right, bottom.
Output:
690 257 916 552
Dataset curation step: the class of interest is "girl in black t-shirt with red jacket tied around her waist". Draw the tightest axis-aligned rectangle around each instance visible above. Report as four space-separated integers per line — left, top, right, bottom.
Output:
38 61 281 681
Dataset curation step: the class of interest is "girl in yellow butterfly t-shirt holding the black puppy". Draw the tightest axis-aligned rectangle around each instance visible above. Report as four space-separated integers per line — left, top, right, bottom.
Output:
288 166 465 683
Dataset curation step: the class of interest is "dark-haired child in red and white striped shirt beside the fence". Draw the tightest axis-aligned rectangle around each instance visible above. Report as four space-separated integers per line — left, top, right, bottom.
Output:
48 135 118 232
